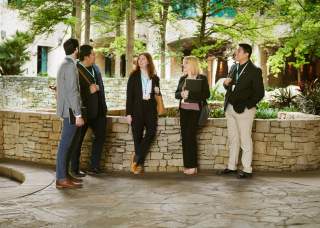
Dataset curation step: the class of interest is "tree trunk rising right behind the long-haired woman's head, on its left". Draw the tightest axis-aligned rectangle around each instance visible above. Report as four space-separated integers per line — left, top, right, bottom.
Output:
126 0 136 76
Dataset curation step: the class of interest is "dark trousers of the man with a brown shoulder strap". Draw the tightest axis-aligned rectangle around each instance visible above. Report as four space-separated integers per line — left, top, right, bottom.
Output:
71 116 106 172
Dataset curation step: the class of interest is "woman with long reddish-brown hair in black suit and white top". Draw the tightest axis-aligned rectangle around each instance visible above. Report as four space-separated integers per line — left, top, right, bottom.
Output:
126 53 160 174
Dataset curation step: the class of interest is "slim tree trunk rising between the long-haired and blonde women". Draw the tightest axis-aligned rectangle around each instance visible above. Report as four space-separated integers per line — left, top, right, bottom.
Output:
159 0 170 78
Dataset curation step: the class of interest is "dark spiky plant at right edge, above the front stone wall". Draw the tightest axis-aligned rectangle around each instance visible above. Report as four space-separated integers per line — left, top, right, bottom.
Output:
297 79 320 115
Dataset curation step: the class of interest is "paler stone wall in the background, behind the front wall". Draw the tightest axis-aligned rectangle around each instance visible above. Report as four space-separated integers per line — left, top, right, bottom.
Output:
0 76 178 110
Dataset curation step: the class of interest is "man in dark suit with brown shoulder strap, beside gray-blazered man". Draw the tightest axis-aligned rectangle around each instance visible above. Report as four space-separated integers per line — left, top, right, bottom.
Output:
72 45 107 177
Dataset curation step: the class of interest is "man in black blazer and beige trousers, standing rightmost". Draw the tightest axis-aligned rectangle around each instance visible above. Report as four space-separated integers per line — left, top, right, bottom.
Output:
221 44 264 178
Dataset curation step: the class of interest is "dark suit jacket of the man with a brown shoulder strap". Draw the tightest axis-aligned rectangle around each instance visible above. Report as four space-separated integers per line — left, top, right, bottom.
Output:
77 64 107 119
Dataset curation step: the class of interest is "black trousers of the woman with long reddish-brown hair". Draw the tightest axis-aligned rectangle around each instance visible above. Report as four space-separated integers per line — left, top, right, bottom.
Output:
131 101 158 165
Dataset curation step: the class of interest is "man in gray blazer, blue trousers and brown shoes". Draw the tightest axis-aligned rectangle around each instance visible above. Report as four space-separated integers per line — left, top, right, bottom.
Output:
56 38 84 189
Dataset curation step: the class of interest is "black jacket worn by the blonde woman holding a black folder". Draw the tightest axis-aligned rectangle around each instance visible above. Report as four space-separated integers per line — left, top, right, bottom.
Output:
175 74 210 108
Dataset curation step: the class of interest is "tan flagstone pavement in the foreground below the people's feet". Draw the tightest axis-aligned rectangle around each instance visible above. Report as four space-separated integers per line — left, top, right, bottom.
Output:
0 163 320 228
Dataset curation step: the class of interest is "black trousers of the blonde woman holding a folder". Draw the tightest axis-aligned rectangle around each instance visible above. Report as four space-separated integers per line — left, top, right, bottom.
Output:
180 109 200 168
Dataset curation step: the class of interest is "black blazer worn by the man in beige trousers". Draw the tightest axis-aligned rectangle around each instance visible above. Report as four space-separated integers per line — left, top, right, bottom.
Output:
224 60 264 113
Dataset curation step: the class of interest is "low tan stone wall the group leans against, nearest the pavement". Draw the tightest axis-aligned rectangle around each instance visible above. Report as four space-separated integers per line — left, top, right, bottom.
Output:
0 111 320 172
